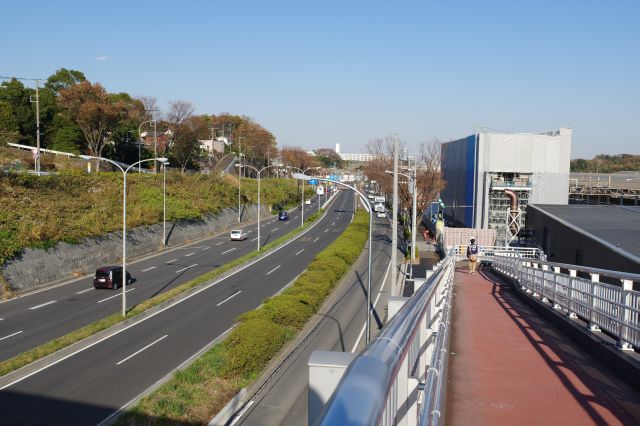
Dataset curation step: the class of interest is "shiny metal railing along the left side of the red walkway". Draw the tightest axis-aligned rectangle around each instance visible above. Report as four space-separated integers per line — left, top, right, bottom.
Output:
318 250 455 425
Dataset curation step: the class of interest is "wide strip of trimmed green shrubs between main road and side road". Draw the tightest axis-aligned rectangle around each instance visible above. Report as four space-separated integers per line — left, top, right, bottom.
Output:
117 211 368 425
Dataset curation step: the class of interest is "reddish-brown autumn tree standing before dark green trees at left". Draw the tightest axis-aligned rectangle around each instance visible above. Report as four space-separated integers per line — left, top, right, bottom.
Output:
58 81 120 161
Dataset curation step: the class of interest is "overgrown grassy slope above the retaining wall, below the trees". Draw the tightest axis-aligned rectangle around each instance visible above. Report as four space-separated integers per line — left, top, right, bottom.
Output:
0 171 310 265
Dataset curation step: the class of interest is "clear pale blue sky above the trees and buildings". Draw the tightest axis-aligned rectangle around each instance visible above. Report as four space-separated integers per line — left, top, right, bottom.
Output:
0 0 640 158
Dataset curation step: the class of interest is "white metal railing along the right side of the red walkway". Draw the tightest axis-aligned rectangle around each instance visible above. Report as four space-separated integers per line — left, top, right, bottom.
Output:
492 255 640 350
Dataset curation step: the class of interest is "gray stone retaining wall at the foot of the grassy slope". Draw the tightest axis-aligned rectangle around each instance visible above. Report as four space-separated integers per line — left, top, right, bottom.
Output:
0 206 270 295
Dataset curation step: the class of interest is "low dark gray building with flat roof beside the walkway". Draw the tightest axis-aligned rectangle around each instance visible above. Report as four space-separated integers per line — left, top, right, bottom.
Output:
526 204 640 274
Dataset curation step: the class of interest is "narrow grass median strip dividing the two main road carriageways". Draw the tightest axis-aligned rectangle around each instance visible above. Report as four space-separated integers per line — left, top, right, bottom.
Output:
0 213 320 376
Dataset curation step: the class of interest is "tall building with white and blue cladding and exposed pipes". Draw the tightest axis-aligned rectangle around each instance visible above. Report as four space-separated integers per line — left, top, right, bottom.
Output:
441 129 572 244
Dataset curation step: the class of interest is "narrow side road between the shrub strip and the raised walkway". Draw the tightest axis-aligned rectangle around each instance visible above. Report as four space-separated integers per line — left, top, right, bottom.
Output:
233 213 398 426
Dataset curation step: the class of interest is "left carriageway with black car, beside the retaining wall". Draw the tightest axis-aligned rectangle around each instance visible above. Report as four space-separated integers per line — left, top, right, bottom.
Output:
0 197 324 361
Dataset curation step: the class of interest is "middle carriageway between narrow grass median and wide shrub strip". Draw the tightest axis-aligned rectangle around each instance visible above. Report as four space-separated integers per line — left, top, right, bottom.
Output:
0 191 353 425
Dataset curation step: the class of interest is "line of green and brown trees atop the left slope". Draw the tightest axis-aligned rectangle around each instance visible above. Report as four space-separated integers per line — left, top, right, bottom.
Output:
0 68 278 172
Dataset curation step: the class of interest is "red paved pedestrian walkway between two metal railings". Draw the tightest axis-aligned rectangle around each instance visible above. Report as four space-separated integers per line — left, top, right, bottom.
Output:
446 268 640 425
